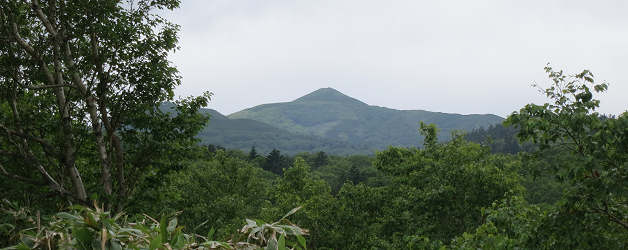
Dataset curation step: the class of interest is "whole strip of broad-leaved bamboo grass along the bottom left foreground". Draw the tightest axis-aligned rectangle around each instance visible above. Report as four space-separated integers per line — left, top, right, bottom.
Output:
0 200 307 250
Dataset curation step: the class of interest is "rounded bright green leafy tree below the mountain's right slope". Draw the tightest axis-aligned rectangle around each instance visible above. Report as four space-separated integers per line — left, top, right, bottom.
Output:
376 136 523 242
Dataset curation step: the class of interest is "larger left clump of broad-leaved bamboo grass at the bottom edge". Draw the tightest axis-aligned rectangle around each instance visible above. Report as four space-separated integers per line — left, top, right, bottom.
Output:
2 202 196 249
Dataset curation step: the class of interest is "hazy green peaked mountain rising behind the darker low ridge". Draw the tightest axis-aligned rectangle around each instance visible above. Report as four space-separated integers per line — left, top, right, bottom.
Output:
229 88 503 149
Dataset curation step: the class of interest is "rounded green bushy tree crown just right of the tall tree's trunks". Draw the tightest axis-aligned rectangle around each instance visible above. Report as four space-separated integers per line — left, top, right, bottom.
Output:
135 151 272 237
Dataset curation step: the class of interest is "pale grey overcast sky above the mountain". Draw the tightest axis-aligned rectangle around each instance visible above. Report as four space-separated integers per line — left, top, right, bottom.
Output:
168 0 628 116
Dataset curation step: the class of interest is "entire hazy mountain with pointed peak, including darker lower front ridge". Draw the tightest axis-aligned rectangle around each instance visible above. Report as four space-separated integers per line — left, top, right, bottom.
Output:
199 88 503 154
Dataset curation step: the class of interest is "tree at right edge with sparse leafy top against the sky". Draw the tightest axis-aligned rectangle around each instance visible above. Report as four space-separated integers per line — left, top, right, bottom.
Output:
506 65 628 238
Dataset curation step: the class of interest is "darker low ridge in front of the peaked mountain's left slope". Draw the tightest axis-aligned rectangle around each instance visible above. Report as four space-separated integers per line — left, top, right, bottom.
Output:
198 109 374 155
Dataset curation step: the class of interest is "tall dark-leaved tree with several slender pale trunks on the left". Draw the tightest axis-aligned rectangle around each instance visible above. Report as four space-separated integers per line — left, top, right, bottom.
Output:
0 0 210 210
